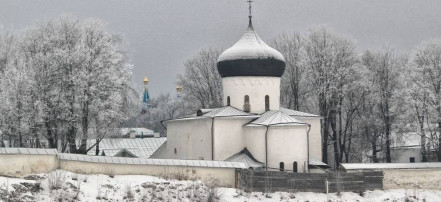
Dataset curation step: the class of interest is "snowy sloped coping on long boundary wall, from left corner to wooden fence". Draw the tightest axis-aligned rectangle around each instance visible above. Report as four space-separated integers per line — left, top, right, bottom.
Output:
59 153 247 169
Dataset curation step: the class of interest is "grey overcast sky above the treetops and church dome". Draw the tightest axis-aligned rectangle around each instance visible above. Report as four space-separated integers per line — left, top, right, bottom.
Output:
0 0 441 96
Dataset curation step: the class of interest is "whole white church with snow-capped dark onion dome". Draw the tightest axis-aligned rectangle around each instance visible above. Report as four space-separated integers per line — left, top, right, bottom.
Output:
151 16 326 172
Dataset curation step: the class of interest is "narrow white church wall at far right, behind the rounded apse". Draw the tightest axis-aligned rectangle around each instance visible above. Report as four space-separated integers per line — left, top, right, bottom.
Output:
295 117 322 160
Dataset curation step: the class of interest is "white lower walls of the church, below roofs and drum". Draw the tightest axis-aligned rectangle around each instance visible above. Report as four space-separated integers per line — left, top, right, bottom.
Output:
160 113 321 172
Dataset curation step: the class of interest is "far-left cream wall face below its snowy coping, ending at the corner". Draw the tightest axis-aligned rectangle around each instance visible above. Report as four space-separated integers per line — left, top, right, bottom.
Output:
0 154 58 177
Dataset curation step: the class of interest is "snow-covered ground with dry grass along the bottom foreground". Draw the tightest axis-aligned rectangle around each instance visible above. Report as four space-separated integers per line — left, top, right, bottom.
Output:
0 170 441 202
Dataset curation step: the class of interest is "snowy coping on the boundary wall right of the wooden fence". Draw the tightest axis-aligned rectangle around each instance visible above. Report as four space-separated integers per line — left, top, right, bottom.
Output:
340 162 441 170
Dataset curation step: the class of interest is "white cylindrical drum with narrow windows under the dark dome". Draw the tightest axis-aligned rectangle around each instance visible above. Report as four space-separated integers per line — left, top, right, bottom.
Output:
222 76 280 113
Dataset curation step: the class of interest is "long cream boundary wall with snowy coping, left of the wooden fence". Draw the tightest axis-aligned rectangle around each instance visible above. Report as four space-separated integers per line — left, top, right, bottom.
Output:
0 153 244 187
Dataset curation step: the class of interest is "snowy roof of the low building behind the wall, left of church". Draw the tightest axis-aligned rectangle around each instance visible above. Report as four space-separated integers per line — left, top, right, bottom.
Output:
87 137 167 158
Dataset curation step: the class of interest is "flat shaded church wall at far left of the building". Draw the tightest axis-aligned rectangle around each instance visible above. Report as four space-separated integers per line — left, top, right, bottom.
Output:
165 118 211 160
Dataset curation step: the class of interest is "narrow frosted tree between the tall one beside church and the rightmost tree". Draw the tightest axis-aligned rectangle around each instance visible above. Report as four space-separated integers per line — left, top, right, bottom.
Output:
363 49 406 163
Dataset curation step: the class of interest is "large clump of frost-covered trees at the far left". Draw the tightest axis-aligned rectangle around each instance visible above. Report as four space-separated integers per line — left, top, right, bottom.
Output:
0 17 131 153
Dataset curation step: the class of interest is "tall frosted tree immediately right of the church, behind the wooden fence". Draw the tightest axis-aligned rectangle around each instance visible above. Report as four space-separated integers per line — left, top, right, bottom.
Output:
305 28 357 165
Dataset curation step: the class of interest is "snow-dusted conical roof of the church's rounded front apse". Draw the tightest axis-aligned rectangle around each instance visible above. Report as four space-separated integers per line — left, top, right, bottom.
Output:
247 111 307 126
